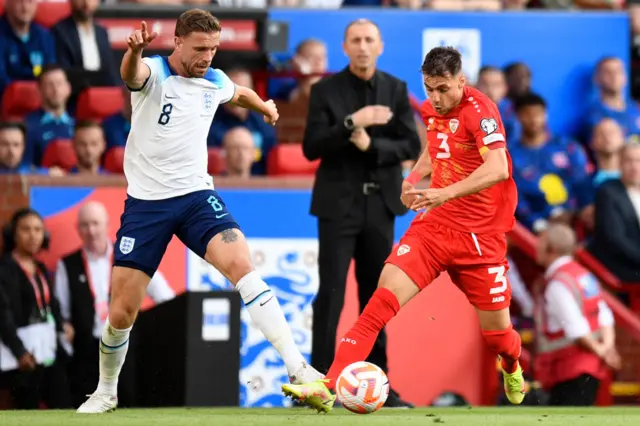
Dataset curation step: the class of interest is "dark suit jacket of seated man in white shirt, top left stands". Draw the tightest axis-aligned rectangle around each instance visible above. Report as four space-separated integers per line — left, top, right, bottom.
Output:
51 16 120 86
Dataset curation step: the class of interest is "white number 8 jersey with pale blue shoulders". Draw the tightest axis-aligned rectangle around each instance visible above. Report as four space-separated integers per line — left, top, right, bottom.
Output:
124 56 235 200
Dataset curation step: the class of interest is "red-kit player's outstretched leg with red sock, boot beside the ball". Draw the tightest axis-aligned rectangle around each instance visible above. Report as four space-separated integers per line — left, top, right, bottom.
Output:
282 263 420 410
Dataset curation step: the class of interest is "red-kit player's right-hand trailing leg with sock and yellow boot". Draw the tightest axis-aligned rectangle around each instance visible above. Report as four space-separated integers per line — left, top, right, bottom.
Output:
476 308 525 404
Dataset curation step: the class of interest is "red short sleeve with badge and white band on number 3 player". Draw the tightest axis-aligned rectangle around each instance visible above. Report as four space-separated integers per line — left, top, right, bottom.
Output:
465 97 507 154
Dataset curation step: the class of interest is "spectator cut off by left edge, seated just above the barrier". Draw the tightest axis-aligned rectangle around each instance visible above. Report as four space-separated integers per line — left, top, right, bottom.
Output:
0 122 65 176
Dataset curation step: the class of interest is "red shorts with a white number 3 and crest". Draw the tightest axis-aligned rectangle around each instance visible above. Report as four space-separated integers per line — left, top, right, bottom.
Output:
386 217 511 311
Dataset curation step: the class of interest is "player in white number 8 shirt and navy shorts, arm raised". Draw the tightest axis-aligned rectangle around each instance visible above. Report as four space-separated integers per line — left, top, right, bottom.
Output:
78 9 322 414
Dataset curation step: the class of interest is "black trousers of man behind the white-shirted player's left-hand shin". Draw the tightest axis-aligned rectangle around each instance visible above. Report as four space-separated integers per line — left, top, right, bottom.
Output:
67 337 135 408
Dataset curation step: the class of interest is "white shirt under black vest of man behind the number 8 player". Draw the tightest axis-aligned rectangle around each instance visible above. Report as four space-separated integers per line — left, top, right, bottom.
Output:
55 244 175 339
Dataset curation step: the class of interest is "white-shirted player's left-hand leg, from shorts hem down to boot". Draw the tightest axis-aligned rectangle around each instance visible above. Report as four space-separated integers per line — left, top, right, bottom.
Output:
78 266 151 414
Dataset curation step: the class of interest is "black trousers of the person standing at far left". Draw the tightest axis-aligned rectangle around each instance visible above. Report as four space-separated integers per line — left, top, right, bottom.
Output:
8 351 71 410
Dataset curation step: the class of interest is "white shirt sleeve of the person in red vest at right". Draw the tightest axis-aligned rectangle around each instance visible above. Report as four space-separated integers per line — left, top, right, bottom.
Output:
545 281 591 340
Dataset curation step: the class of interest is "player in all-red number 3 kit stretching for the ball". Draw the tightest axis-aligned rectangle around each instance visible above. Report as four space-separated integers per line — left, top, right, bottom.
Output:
283 47 525 412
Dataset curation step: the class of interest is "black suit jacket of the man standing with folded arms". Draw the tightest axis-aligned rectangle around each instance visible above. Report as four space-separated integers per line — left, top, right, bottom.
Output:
302 69 420 219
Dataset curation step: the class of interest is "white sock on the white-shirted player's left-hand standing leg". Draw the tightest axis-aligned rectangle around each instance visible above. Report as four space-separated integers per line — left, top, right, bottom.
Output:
96 317 132 396
